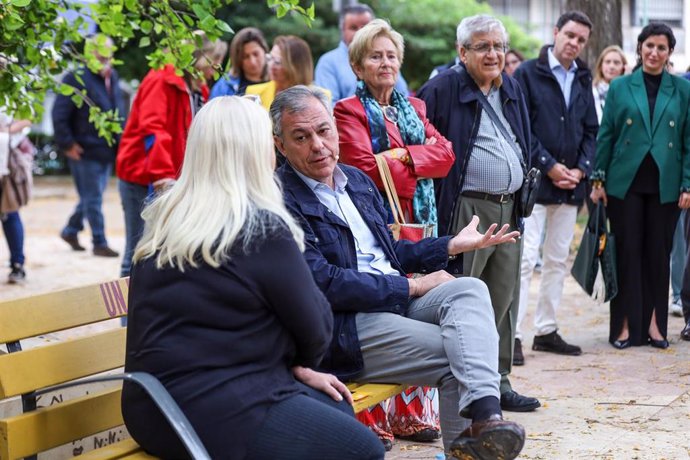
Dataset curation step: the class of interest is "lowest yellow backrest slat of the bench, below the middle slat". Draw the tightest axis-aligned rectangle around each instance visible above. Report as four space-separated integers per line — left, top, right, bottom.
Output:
0 388 124 460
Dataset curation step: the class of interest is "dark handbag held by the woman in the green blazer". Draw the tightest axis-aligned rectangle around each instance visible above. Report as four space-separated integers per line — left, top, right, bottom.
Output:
570 201 618 302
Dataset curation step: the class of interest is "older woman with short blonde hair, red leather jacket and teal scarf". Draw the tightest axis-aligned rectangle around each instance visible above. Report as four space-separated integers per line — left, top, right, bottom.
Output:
335 19 455 449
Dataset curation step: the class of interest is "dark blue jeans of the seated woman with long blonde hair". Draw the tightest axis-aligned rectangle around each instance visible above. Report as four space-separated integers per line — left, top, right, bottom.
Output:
247 385 385 460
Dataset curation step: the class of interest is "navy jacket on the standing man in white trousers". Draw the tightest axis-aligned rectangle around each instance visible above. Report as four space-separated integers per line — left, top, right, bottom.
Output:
515 45 599 206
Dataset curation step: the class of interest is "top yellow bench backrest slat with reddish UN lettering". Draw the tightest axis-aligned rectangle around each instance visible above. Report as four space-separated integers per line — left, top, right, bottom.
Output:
0 278 129 343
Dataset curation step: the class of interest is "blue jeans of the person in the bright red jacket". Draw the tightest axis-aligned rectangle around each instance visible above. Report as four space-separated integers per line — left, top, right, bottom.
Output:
117 179 149 276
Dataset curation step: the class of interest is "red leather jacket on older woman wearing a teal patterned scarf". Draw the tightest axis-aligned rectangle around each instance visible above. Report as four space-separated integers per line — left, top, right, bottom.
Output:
334 96 455 222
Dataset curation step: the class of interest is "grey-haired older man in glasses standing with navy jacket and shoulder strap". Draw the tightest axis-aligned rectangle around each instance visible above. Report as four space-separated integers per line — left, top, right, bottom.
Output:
418 15 541 412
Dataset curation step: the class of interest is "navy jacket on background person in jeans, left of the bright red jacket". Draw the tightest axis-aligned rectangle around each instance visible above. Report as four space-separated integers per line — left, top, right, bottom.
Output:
52 67 125 163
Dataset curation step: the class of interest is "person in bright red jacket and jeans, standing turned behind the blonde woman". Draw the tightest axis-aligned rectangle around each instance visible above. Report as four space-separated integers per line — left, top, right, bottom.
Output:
116 33 227 276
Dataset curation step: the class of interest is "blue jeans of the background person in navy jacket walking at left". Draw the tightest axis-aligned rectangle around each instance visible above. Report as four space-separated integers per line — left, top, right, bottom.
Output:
62 158 112 247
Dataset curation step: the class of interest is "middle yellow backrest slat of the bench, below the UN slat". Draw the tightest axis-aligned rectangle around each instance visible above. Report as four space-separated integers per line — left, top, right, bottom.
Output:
0 327 126 399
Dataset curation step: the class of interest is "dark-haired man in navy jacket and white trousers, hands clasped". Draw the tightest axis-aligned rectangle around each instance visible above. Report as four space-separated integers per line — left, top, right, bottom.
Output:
514 11 598 365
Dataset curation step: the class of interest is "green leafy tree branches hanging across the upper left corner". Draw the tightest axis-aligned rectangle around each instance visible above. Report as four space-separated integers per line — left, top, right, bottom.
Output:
0 0 314 141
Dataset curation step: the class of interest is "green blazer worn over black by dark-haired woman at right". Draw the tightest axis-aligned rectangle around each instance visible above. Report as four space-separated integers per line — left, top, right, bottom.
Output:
592 69 690 203
